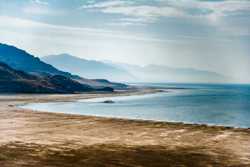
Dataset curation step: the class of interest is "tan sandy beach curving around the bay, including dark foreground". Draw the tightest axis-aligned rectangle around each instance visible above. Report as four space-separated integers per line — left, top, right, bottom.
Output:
0 90 250 167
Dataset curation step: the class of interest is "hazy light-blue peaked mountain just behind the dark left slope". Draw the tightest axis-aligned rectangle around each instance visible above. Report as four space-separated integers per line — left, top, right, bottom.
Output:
41 54 135 82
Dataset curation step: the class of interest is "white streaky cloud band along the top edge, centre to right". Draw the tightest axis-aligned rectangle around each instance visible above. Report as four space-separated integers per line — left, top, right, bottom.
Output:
81 0 250 24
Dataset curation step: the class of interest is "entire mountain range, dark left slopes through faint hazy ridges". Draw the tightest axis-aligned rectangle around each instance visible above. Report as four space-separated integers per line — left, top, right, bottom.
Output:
0 44 230 93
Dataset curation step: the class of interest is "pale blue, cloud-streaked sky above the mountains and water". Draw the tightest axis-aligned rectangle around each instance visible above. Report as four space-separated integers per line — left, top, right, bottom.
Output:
0 0 250 83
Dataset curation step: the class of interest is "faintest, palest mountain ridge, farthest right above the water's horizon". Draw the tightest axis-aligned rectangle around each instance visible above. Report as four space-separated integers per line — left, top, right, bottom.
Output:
106 62 232 83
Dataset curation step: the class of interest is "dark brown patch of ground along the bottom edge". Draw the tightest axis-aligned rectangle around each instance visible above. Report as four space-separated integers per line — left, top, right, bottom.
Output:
0 143 247 167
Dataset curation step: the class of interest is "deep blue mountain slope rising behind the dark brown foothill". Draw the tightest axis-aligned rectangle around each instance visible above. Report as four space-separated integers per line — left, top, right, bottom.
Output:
0 43 127 89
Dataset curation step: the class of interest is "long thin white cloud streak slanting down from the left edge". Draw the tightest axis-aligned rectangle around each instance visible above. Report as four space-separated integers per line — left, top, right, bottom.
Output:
0 16 174 42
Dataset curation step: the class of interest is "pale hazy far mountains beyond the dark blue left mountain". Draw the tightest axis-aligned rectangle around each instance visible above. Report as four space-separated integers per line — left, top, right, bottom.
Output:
42 54 231 83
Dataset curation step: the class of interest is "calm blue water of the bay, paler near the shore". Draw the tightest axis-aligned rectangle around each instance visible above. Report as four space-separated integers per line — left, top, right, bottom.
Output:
21 84 250 128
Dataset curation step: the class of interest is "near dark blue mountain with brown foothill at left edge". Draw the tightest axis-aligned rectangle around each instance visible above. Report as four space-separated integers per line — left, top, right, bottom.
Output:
0 44 128 93
